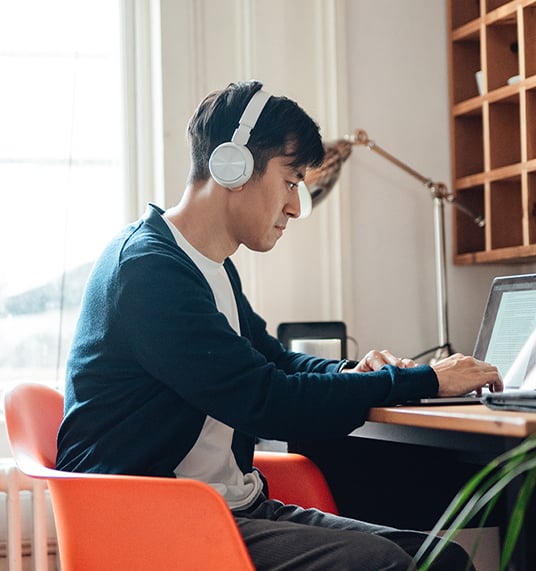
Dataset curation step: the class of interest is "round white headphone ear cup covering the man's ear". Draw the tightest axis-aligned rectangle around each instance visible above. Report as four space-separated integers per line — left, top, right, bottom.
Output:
208 142 253 188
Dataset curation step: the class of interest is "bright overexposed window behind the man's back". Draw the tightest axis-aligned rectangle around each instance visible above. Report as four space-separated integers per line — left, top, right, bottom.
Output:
0 0 127 392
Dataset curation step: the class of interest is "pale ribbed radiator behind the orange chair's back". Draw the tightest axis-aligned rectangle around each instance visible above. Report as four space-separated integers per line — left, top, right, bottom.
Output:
0 458 60 571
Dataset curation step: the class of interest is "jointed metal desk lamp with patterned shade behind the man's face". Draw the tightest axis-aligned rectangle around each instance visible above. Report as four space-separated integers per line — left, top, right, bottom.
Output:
305 129 485 363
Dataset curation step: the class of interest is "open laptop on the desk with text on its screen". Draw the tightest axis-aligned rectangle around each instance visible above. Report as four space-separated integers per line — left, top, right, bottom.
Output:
411 274 536 405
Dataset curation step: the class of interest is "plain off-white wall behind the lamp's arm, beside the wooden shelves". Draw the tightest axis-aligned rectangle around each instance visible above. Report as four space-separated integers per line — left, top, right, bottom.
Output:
347 0 534 355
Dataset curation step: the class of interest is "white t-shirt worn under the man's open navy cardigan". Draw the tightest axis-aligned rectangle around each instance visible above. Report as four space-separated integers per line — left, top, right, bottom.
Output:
163 216 262 509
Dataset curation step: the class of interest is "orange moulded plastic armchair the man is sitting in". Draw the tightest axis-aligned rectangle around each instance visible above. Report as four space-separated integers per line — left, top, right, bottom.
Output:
4 383 336 571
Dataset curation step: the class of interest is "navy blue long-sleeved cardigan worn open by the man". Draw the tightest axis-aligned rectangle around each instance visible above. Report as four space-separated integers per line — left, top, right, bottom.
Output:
57 206 438 477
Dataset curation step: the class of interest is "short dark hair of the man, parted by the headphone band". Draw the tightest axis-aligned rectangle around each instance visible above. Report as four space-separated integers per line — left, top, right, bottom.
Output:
188 81 324 182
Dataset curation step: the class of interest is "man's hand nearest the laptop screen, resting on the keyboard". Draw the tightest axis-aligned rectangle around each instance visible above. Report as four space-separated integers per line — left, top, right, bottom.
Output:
432 353 503 397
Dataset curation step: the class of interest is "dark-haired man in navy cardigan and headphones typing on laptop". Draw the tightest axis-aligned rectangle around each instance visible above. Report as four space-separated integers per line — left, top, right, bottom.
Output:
57 81 501 571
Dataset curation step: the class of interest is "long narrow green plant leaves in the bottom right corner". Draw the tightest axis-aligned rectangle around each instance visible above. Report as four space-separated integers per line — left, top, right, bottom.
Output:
415 434 536 571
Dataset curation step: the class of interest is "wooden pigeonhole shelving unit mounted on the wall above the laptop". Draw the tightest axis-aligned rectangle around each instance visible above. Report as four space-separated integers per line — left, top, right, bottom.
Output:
448 0 536 264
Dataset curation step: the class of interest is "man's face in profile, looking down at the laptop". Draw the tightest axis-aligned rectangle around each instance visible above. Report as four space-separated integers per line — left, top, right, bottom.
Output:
230 156 305 252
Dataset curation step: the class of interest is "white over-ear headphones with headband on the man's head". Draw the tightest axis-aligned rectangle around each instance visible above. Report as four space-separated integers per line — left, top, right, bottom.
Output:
208 89 271 188
